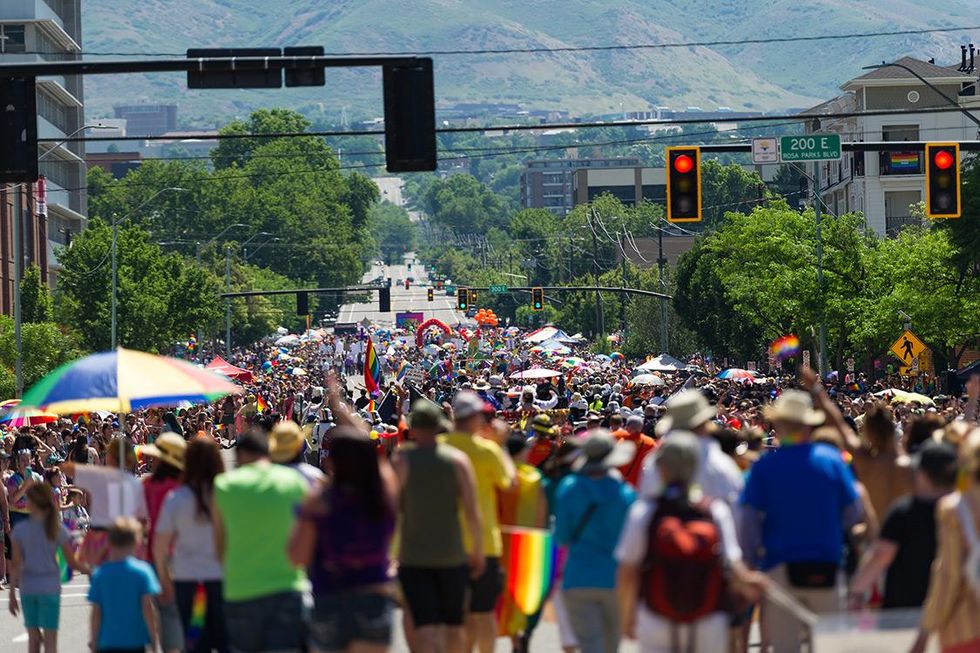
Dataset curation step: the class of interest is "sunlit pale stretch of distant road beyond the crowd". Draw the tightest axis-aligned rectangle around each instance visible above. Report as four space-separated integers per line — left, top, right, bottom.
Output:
337 254 462 326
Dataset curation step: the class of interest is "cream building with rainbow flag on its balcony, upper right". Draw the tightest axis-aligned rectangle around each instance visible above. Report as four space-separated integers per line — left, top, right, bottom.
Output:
804 57 980 235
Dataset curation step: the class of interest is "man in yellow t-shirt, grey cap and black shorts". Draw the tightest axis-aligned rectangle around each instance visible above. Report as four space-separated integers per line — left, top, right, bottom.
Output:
443 390 515 653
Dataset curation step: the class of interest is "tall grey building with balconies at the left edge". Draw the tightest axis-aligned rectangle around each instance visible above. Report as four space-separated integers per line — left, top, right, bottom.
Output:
0 0 86 306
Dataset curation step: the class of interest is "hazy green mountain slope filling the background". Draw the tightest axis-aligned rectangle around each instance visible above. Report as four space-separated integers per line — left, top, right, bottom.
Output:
82 0 980 126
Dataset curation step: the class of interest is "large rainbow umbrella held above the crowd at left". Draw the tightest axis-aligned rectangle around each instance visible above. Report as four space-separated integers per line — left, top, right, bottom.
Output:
21 347 242 415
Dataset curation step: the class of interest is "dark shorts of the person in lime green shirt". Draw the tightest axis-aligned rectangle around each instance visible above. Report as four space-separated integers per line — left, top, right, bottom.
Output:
225 592 309 653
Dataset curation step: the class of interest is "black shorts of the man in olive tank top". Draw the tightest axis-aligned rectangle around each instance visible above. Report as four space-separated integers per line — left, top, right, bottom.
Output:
398 565 470 628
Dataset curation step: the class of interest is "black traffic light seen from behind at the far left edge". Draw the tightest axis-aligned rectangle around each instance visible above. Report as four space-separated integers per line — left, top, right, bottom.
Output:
0 77 37 183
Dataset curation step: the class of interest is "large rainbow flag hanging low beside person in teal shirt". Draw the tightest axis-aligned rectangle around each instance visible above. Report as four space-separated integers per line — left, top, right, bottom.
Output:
504 527 556 615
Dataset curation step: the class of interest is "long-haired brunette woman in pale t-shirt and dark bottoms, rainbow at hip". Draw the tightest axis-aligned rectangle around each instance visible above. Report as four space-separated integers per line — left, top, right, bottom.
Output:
152 437 228 653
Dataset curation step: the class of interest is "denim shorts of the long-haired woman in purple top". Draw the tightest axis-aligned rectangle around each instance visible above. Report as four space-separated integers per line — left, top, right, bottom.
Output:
309 592 394 652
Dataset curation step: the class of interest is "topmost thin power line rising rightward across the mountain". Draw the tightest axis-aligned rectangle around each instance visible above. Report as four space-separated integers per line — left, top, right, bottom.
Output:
17 25 980 57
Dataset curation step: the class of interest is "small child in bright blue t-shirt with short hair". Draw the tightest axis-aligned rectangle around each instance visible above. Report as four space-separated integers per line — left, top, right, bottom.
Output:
88 517 160 651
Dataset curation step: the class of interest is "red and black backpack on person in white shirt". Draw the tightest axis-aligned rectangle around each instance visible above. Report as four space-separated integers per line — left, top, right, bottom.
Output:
640 499 728 624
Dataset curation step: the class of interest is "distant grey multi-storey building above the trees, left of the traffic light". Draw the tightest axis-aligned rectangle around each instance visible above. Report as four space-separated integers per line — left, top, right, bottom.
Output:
521 157 640 216
